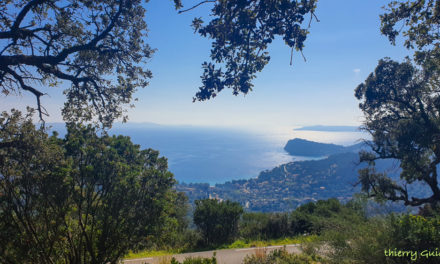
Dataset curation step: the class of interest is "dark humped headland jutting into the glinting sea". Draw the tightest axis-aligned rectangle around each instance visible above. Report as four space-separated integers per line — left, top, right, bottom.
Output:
284 138 367 157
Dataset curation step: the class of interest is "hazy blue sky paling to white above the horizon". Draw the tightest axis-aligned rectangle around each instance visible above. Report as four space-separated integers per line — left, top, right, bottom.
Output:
0 0 409 131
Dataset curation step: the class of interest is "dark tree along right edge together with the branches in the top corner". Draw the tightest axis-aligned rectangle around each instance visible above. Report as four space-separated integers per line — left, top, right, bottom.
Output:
355 0 440 206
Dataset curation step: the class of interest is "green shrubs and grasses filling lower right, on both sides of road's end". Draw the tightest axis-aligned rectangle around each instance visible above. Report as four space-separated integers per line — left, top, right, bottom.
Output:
125 197 440 264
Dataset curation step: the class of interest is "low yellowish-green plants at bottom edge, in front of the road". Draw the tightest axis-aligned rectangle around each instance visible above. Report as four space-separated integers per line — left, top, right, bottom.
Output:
243 249 322 264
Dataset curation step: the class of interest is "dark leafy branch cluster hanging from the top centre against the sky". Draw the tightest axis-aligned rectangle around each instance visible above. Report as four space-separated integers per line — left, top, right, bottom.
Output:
181 0 317 101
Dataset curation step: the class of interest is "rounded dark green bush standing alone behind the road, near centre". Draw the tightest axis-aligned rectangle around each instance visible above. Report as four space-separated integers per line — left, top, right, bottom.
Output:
193 199 243 245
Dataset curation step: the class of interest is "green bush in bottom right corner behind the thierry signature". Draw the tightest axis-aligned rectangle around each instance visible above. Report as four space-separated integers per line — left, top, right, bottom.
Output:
322 215 440 264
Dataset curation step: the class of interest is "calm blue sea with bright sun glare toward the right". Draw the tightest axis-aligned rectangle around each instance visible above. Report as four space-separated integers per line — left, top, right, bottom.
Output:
48 123 365 185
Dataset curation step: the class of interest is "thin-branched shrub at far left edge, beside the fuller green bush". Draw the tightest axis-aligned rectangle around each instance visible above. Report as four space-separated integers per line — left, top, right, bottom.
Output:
0 108 70 263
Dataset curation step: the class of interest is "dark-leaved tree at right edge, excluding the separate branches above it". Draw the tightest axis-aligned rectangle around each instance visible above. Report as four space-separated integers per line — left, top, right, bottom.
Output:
356 59 440 206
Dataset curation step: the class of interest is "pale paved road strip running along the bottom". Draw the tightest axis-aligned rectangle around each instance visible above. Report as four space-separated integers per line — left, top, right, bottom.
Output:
123 244 301 264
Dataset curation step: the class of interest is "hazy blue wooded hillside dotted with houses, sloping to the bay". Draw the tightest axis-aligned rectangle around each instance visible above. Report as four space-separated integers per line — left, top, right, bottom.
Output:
177 147 418 212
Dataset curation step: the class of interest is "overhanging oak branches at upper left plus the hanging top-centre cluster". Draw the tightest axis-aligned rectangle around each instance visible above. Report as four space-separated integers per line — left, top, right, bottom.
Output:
0 0 316 126
